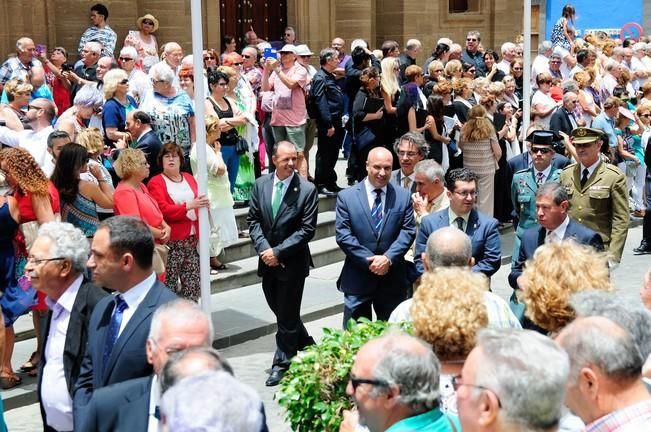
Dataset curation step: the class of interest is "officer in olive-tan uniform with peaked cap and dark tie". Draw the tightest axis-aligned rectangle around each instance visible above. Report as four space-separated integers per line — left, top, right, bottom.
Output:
561 127 629 264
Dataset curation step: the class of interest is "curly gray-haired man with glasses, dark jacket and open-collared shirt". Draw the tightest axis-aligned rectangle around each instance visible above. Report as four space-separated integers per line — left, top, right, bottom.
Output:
25 222 108 432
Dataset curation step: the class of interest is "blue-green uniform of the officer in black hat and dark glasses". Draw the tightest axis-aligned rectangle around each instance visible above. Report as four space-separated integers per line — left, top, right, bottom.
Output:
511 165 561 262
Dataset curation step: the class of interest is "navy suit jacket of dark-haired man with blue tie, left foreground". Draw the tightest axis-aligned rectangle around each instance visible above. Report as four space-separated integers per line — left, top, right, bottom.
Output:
73 280 177 424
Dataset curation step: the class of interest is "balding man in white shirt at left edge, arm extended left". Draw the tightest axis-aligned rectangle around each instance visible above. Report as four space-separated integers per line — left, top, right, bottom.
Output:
0 98 56 178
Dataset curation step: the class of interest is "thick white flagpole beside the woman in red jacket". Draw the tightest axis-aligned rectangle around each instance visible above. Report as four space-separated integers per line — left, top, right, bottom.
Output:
190 0 212 314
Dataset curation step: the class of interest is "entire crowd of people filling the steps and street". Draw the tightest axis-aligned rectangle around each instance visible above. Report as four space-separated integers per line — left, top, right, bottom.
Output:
0 0 651 432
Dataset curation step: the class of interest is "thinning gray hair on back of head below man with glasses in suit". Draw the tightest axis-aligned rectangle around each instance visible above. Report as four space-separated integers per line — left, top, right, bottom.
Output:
425 226 472 270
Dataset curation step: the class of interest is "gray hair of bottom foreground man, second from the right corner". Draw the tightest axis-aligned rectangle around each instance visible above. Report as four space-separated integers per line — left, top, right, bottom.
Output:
474 329 569 430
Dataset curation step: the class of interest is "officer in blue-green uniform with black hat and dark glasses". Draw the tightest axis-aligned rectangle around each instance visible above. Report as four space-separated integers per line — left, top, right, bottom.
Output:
511 130 562 263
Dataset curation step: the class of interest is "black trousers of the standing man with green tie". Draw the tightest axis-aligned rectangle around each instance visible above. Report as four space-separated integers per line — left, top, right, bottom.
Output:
262 274 314 369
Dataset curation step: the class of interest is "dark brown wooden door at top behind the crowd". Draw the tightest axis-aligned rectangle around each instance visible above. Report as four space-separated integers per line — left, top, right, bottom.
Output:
219 0 287 49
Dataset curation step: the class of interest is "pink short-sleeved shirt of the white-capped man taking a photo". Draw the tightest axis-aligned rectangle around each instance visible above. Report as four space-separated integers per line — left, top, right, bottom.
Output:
269 63 308 126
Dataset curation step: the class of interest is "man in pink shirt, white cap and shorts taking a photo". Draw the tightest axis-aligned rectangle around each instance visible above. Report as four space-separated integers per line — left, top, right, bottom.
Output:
262 44 308 177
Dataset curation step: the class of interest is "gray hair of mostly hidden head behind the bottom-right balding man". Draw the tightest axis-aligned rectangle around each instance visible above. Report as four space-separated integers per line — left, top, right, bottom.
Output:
570 290 651 358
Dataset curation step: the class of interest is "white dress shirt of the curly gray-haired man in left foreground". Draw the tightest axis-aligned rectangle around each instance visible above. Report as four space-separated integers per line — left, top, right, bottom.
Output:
41 275 84 431
